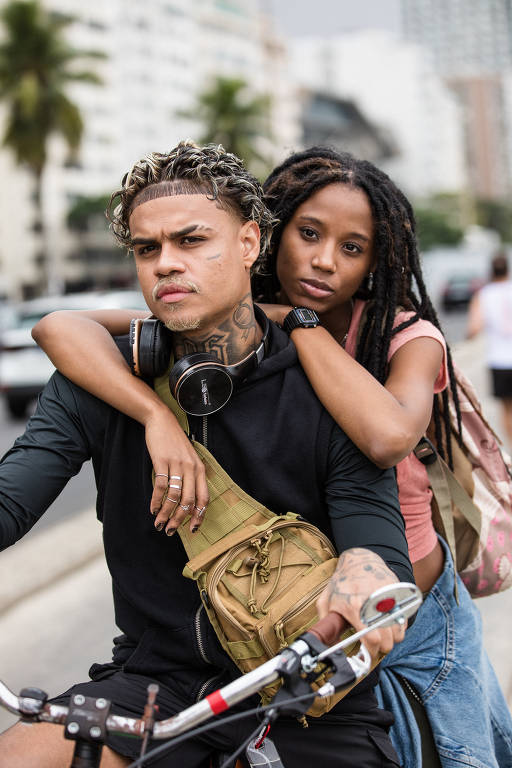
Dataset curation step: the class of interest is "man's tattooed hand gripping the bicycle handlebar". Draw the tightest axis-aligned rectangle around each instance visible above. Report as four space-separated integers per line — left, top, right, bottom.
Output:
316 547 407 658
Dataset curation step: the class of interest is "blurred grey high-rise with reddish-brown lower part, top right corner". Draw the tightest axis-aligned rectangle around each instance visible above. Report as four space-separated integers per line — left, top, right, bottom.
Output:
401 0 512 198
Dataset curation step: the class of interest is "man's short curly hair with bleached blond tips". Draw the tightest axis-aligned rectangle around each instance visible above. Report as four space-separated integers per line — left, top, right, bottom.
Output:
106 139 275 253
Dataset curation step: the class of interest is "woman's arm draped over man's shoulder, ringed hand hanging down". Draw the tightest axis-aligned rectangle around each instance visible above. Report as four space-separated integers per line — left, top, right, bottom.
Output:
32 310 208 532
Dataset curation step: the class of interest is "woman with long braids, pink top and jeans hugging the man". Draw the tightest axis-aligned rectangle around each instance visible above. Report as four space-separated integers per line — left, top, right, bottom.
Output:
34 148 512 768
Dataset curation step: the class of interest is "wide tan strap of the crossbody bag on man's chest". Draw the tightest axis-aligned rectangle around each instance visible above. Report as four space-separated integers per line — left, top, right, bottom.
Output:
154 363 277 567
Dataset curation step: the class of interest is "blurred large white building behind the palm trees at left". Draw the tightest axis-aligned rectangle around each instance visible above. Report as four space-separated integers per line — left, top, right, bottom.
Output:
0 0 298 294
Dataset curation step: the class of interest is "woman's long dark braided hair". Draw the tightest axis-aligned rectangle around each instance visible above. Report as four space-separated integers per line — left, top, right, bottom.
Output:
253 147 461 465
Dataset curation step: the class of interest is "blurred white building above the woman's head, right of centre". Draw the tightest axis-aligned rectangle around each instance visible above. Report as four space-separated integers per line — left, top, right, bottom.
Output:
291 30 466 196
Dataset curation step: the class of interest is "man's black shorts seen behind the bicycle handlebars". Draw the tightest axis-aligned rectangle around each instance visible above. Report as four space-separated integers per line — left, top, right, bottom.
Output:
52 671 399 768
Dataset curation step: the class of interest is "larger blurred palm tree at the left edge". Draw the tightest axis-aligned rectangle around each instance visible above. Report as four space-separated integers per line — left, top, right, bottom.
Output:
0 0 103 292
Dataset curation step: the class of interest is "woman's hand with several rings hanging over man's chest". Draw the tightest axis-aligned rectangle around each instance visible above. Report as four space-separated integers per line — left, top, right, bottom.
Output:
144 406 209 536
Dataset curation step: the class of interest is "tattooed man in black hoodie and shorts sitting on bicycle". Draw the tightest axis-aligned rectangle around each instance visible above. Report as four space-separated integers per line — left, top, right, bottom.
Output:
0 142 412 768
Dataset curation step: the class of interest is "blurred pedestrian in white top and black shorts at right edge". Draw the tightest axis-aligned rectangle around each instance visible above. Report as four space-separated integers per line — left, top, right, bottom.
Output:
467 251 512 447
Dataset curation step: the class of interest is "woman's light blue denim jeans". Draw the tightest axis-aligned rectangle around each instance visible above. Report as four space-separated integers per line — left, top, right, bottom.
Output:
376 539 512 768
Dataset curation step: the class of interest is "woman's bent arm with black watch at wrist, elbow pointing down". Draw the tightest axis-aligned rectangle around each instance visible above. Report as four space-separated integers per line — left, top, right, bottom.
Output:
262 296 443 468
